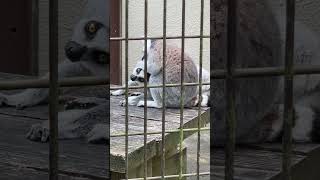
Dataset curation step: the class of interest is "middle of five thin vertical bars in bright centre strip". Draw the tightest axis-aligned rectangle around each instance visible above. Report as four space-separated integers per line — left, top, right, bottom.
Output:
161 0 167 179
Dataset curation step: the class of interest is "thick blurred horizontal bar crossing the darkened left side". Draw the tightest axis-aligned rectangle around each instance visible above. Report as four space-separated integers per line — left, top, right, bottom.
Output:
0 77 109 90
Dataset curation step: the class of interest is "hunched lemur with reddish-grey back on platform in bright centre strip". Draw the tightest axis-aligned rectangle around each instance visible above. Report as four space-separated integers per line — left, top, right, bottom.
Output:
116 41 198 108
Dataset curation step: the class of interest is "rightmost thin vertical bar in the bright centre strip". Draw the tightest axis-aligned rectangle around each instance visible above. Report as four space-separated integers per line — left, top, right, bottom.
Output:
197 0 204 180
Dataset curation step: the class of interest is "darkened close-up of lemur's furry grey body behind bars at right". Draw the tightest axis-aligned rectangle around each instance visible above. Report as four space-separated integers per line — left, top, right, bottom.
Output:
210 0 320 145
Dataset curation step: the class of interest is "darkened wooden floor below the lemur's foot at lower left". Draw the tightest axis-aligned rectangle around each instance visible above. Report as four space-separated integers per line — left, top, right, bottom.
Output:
0 106 109 180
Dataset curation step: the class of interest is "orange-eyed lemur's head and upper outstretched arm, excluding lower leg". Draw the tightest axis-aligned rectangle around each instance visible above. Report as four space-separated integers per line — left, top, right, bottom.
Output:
0 0 109 108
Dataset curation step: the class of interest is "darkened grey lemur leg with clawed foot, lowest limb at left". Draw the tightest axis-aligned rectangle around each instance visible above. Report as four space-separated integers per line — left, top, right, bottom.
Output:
26 102 109 142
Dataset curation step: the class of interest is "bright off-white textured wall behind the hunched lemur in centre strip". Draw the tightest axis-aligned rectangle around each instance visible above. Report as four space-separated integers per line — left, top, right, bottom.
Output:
122 0 210 82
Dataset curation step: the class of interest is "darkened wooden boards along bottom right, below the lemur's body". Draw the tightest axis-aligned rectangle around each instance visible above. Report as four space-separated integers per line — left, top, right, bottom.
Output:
212 144 320 180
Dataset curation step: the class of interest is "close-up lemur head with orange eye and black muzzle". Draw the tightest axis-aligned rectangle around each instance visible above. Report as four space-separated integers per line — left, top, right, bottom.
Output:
65 0 109 64
